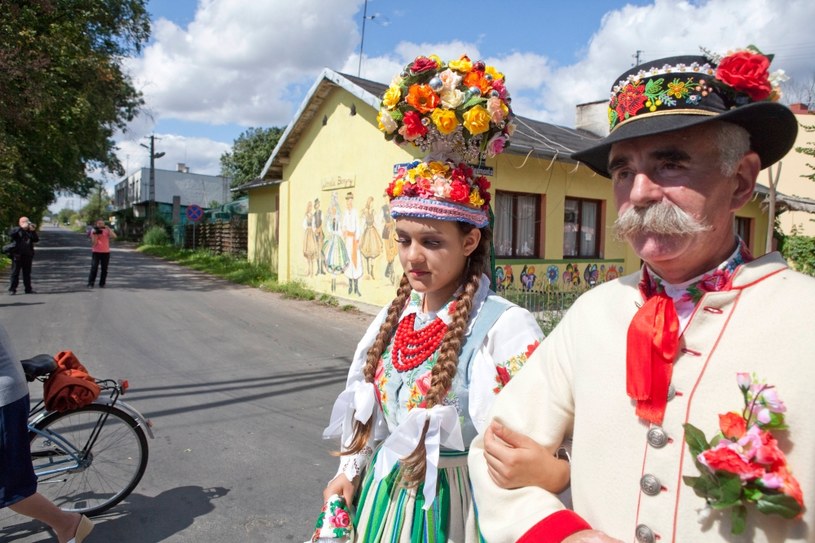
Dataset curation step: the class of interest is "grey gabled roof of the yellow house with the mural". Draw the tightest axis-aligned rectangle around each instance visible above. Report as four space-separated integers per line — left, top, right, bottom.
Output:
258 68 600 182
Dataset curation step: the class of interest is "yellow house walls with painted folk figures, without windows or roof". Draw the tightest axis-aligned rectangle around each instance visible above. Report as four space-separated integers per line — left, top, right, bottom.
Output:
249 81 767 306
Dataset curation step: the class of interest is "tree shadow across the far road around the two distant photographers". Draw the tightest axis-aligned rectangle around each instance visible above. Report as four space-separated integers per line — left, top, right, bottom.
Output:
2 227 247 296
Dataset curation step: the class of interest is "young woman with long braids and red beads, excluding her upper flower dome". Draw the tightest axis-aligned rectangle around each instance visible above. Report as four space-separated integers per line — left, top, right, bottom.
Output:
315 162 568 542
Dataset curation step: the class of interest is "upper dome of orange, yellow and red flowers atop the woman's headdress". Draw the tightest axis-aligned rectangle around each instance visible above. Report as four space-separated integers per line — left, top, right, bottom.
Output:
378 55 512 163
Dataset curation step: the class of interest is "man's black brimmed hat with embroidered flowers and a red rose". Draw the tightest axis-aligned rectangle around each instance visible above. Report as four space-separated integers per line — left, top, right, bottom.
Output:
572 45 798 177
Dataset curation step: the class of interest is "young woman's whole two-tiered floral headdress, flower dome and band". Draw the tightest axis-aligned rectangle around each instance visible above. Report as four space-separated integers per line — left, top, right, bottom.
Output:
377 55 514 228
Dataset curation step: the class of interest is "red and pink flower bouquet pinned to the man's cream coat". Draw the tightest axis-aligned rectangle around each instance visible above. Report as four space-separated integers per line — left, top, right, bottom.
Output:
683 373 804 534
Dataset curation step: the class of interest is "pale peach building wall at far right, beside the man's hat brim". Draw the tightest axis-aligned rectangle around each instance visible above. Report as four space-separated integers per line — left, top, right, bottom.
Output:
776 113 815 236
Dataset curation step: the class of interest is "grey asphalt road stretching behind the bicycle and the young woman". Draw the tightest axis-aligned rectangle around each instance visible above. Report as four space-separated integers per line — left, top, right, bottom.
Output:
0 227 373 543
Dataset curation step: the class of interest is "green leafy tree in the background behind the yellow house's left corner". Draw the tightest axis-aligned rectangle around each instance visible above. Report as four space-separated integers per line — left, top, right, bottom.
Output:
221 127 283 188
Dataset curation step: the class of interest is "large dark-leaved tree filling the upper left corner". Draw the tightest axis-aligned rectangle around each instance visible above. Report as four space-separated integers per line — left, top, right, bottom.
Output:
0 0 150 230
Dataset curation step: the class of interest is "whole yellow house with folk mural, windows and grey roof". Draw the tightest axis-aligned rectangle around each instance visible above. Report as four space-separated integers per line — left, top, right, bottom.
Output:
241 69 767 305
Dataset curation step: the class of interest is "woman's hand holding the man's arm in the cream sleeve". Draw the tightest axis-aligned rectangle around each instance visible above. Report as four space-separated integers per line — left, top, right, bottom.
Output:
484 421 570 493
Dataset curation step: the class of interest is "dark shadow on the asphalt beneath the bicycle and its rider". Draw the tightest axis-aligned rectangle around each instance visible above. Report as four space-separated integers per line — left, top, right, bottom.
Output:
0 486 229 543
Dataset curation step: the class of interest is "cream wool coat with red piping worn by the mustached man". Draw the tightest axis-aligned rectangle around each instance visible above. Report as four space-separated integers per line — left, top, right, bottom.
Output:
469 253 815 543
